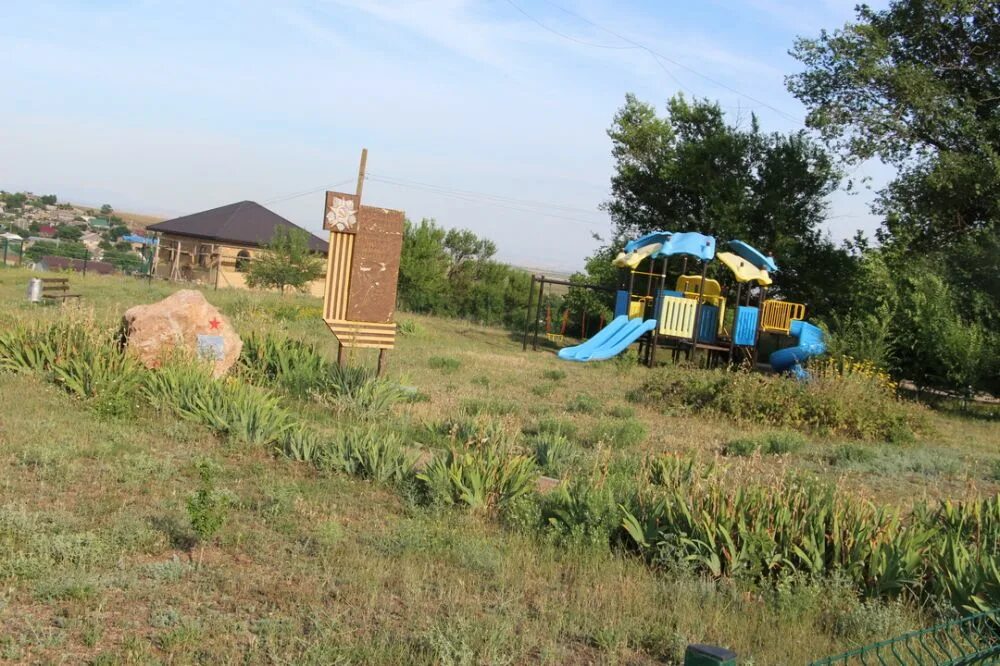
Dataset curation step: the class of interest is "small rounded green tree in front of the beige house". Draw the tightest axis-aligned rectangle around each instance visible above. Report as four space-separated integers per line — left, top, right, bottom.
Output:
246 227 323 293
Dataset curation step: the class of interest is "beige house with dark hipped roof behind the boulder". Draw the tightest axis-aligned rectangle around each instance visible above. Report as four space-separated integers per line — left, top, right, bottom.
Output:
146 201 327 296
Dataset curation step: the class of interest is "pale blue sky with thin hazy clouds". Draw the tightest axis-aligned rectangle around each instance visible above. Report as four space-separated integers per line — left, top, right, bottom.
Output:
0 0 890 269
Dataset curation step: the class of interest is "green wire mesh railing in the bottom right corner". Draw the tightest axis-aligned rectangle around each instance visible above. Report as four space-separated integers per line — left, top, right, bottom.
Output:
810 609 1000 666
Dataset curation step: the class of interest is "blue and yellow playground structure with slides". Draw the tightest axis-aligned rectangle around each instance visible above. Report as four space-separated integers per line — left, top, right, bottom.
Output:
552 231 826 379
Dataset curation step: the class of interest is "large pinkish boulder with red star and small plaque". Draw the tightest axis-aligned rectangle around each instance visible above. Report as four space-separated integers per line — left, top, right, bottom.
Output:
123 289 243 377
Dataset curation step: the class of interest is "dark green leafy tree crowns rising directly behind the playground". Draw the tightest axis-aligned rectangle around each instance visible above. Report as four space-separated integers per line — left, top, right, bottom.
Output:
606 95 851 313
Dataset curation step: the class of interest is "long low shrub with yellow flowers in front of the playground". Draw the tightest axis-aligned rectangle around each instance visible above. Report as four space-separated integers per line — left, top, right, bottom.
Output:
629 369 922 442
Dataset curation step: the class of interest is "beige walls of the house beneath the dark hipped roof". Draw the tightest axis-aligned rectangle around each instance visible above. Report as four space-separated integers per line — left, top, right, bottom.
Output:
156 234 326 298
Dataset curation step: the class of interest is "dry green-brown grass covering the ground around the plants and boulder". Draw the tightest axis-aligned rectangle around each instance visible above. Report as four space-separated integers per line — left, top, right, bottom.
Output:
0 269 1000 664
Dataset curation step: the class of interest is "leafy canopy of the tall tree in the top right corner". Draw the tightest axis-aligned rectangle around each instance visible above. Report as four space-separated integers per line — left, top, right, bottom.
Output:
788 0 1000 247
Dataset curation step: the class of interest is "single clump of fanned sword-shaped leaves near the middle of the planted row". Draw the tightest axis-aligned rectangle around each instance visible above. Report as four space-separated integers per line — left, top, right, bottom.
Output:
417 443 538 512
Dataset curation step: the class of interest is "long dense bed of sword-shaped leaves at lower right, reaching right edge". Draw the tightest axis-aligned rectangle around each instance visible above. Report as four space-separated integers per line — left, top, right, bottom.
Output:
622 472 1000 612
